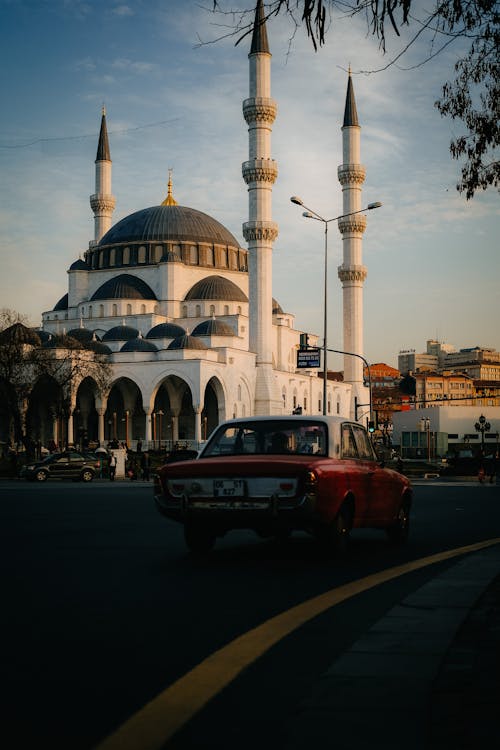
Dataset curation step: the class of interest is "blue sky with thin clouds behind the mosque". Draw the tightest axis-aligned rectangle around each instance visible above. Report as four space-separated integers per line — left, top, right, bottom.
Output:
0 0 500 369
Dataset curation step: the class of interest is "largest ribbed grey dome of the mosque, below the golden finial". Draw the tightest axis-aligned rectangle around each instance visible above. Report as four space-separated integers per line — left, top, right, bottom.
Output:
99 205 239 248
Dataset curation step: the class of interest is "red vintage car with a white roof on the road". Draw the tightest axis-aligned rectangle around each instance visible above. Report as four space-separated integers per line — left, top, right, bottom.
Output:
154 416 412 553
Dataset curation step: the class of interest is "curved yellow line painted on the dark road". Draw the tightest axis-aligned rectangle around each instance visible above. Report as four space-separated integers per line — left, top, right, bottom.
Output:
96 537 500 750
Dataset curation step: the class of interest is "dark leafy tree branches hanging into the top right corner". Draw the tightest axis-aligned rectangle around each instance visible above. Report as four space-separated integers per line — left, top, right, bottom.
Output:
212 0 500 199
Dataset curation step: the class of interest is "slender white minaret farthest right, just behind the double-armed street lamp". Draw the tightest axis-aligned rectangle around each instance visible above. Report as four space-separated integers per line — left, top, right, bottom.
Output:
338 68 367 416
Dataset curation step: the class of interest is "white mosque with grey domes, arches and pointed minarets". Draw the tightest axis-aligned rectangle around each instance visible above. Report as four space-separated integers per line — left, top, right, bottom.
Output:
20 0 367 446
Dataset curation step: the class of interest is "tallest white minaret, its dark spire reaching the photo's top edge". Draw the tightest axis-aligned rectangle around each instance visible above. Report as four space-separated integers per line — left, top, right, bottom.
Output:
242 0 282 414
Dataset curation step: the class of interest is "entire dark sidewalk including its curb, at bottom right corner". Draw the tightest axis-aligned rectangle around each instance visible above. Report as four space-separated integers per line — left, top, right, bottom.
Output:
286 545 500 750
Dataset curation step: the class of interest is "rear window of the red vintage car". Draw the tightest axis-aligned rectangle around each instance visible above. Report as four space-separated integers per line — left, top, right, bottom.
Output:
201 419 328 458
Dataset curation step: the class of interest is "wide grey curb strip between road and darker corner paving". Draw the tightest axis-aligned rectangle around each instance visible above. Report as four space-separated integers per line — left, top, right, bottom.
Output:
286 545 500 750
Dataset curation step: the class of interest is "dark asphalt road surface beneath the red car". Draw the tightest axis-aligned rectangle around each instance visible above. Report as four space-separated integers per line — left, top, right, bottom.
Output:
0 481 500 750
